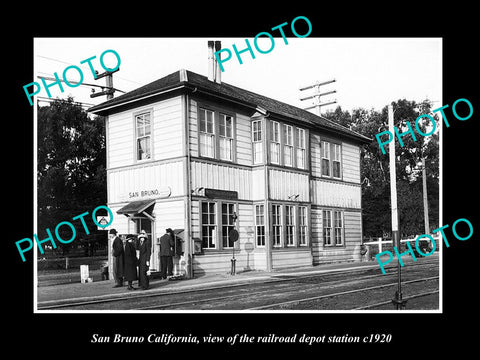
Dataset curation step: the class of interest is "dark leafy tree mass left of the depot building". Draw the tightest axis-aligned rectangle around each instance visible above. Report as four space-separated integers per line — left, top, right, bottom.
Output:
37 97 107 251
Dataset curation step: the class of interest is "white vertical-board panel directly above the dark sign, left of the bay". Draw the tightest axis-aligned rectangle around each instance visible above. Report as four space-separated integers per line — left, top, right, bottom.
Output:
191 161 252 200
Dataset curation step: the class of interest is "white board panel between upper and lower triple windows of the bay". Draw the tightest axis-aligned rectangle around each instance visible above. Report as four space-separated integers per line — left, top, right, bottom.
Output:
268 169 310 202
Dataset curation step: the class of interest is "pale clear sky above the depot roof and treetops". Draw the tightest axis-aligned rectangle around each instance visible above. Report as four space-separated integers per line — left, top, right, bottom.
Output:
31 37 442 112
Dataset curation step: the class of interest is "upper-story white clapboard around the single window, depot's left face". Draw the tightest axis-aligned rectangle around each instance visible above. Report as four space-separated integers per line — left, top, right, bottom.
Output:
107 96 184 168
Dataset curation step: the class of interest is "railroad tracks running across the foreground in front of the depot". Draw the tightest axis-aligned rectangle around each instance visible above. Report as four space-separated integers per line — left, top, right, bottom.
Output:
38 262 438 310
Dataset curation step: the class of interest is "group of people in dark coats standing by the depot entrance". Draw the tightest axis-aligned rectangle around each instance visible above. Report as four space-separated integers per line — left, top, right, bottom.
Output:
108 228 175 290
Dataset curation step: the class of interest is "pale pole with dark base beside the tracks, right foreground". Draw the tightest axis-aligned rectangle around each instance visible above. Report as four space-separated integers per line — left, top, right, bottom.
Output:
388 105 406 310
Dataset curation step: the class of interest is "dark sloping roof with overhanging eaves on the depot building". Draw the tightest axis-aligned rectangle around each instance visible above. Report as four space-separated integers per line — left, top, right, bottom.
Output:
88 70 371 143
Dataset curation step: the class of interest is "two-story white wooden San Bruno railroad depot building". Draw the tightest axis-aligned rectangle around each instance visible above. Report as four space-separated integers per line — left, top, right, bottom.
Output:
89 55 370 277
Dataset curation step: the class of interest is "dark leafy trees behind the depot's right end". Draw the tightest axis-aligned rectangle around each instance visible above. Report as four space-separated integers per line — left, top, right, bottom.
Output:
324 99 439 237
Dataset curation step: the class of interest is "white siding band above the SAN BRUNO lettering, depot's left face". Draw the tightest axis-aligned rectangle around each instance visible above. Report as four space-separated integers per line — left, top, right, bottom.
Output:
107 160 185 203
